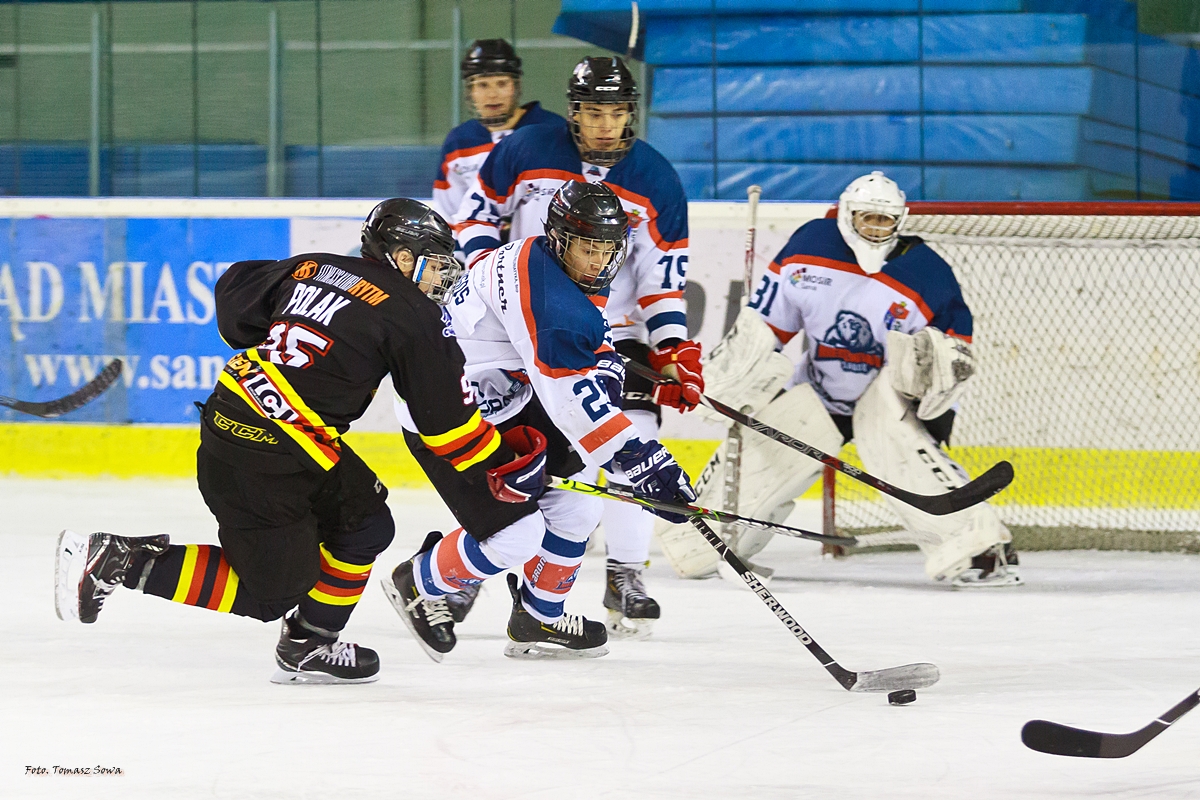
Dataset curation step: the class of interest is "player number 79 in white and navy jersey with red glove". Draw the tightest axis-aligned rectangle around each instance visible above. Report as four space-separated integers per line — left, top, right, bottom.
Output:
452 58 704 636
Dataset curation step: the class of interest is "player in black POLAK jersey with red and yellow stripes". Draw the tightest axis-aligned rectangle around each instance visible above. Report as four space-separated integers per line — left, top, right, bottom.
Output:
55 199 514 684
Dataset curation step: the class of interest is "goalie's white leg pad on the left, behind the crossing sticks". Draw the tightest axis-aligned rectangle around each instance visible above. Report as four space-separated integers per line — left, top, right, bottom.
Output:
656 384 842 578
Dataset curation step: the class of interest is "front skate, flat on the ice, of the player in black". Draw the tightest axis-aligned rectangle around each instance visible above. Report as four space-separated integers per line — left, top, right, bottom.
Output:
271 610 379 684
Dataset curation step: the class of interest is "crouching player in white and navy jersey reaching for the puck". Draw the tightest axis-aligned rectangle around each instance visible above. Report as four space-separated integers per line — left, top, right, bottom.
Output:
384 181 696 660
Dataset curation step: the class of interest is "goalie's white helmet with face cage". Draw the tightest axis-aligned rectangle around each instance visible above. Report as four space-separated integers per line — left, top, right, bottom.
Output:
838 170 908 275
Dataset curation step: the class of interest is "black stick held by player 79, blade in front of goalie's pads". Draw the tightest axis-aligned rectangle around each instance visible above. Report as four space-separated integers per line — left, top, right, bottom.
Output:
625 361 1013 516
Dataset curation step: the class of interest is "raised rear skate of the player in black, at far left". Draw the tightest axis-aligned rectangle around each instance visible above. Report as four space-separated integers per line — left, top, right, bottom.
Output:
54 530 170 624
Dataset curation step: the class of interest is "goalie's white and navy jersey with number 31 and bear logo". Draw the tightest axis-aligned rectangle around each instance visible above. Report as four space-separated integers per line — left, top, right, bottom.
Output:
749 219 972 415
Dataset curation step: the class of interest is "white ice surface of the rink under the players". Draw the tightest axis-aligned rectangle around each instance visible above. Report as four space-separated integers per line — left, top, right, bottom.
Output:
0 480 1200 800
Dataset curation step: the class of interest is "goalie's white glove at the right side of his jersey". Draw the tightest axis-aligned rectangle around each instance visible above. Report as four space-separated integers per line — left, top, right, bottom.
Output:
888 327 976 420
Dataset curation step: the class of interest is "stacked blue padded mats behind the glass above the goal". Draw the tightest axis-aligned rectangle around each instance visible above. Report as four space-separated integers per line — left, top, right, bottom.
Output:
571 0 1200 200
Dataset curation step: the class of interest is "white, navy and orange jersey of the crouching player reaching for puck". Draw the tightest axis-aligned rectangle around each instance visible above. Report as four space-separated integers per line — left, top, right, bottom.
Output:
400 236 637 467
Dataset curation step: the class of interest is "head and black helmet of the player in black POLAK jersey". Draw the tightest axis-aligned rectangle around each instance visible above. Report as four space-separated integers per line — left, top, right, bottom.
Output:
362 198 463 306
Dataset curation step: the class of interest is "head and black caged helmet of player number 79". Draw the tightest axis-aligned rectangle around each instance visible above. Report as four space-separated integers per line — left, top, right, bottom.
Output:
566 56 640 167
